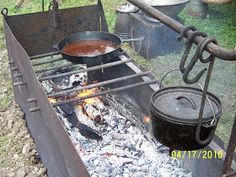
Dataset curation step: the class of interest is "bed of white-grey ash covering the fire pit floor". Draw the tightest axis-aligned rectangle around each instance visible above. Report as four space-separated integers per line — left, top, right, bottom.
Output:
40 72 192 177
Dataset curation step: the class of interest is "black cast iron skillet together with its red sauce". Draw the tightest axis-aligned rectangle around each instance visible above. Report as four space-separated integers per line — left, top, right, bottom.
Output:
53 31 143 66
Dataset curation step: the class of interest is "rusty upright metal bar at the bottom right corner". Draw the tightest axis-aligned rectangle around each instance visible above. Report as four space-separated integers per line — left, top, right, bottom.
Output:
223 116 236 176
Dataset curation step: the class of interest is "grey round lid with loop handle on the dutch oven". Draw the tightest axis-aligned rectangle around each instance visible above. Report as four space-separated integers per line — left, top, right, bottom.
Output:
151 87 221 123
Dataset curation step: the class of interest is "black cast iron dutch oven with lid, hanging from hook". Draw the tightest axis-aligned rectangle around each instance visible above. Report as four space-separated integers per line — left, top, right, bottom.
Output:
151 86 222 150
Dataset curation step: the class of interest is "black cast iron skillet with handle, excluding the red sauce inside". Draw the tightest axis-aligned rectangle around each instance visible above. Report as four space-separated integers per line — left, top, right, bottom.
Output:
53 31 144 66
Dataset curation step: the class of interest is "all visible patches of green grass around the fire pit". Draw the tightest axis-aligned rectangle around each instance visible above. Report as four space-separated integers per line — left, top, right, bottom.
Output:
0 0 236 145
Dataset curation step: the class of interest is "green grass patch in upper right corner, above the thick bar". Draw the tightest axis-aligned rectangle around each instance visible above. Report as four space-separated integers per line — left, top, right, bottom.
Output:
180 1 236 49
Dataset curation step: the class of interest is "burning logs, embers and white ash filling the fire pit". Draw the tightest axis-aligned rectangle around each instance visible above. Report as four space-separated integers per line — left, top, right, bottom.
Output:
42 66 192 177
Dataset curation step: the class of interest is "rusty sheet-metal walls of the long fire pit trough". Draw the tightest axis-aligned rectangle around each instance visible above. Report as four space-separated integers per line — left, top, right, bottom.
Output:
3 0 236 177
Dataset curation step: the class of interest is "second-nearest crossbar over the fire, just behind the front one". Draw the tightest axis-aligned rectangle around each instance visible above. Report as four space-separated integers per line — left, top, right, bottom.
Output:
48 72 150 97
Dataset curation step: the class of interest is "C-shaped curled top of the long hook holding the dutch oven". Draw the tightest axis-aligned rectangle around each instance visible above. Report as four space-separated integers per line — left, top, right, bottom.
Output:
198 38 218 63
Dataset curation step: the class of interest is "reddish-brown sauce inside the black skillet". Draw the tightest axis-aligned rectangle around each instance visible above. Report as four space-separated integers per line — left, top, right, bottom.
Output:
62 40 118 57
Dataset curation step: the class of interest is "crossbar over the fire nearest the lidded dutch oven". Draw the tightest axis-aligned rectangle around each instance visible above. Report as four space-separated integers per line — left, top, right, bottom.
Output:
52 80 158 107
